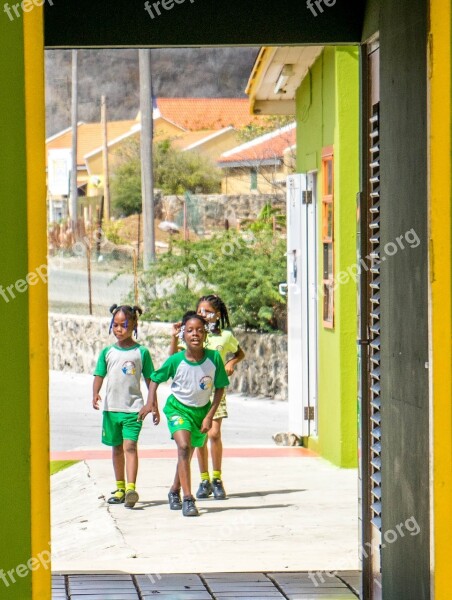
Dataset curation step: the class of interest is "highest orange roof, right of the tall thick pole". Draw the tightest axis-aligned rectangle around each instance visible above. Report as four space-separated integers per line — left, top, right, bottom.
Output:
157 98 262 131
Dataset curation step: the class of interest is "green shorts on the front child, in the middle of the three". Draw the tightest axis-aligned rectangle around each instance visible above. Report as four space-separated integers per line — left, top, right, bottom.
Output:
163 394 212 448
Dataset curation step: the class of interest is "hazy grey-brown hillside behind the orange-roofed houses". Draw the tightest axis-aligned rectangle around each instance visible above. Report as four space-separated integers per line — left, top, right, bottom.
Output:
45 48 258 136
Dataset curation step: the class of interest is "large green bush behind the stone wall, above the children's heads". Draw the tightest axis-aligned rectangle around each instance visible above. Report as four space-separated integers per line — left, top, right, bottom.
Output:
140 230 286 331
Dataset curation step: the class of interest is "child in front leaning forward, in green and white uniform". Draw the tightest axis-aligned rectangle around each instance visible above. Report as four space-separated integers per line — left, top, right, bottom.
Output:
139 312 229 517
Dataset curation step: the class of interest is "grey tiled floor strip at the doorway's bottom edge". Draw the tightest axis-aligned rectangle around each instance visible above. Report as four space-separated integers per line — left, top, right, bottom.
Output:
52 571 360 600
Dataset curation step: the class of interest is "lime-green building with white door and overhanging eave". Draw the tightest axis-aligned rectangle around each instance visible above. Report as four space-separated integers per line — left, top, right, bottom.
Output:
246 46 359 467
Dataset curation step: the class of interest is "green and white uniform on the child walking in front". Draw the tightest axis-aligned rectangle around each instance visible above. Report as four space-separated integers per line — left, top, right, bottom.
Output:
151 349 229 447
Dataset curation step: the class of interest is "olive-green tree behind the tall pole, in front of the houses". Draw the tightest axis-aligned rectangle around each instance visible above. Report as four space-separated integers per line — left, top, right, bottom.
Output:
111 139 221 216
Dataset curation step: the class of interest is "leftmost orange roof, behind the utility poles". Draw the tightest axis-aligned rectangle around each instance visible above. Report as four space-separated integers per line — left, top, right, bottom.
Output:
46 121 137 165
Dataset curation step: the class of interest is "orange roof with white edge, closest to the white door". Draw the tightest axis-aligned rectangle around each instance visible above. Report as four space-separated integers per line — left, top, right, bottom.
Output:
218 123 296 167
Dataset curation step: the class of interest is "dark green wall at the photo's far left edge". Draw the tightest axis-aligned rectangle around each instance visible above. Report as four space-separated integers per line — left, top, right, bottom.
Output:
0 14 32 600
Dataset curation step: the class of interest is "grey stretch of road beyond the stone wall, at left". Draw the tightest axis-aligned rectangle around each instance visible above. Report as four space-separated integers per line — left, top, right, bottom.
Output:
49 266 133 306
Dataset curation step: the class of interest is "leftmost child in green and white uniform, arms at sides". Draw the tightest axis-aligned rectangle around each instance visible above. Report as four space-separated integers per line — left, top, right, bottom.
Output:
93 304 154 508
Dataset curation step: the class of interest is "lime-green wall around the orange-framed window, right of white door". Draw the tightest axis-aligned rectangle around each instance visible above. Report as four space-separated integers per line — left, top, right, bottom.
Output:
296 47 359 467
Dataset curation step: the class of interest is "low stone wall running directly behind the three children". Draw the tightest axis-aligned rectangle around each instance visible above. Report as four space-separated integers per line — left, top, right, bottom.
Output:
49 313 287 400
